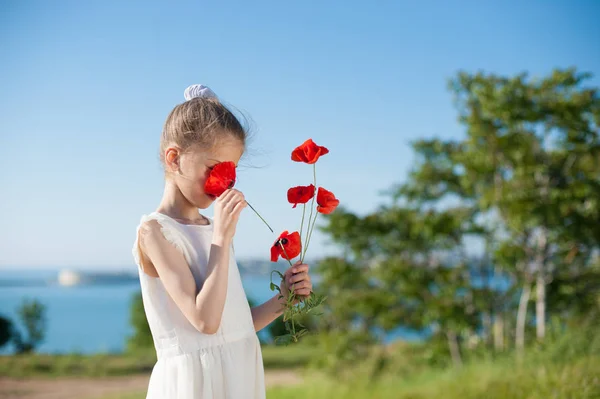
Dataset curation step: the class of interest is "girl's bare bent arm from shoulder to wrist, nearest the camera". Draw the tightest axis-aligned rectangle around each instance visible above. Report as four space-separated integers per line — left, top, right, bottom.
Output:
140 220 231 334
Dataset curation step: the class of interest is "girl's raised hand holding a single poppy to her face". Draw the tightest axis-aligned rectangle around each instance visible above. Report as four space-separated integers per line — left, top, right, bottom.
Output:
213 189 248 246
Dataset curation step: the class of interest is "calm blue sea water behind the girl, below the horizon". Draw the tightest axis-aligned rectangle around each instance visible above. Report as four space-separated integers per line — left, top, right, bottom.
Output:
0 268 419 355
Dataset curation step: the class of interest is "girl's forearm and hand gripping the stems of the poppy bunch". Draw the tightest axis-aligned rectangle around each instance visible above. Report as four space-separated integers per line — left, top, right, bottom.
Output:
251 262 312 331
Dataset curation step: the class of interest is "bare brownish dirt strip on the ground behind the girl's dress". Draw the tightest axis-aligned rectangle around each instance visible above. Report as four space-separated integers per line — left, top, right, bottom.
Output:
0 370 301 399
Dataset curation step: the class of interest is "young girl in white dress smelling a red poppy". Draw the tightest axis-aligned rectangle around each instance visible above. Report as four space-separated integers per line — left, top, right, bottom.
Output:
133 85 312 399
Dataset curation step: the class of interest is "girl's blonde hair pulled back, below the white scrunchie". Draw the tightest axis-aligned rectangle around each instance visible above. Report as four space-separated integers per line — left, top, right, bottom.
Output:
160 97 248 165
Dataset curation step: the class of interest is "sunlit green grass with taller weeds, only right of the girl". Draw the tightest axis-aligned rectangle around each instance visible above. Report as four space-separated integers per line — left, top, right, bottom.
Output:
268 325 600 399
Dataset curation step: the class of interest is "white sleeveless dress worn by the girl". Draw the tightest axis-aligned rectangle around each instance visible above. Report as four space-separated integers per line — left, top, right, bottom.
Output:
133 212 265 399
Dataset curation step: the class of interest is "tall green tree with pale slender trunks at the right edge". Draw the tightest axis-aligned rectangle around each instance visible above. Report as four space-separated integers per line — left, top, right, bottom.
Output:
398 69 600 356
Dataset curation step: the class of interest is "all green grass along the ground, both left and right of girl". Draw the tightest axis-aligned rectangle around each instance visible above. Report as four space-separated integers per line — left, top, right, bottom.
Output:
5 329 600 399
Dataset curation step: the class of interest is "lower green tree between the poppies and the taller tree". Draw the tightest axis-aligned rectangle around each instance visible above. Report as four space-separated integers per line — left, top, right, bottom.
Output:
319 204 478 365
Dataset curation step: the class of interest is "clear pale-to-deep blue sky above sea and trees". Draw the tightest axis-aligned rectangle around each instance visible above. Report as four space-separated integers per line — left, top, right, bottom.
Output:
0 0 600 268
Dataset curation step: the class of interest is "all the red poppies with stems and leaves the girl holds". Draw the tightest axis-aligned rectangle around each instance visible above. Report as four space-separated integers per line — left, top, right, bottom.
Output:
205 139 339 344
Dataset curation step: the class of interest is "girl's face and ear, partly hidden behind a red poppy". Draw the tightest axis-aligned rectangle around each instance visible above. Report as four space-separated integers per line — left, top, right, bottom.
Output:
165 138 244 209
